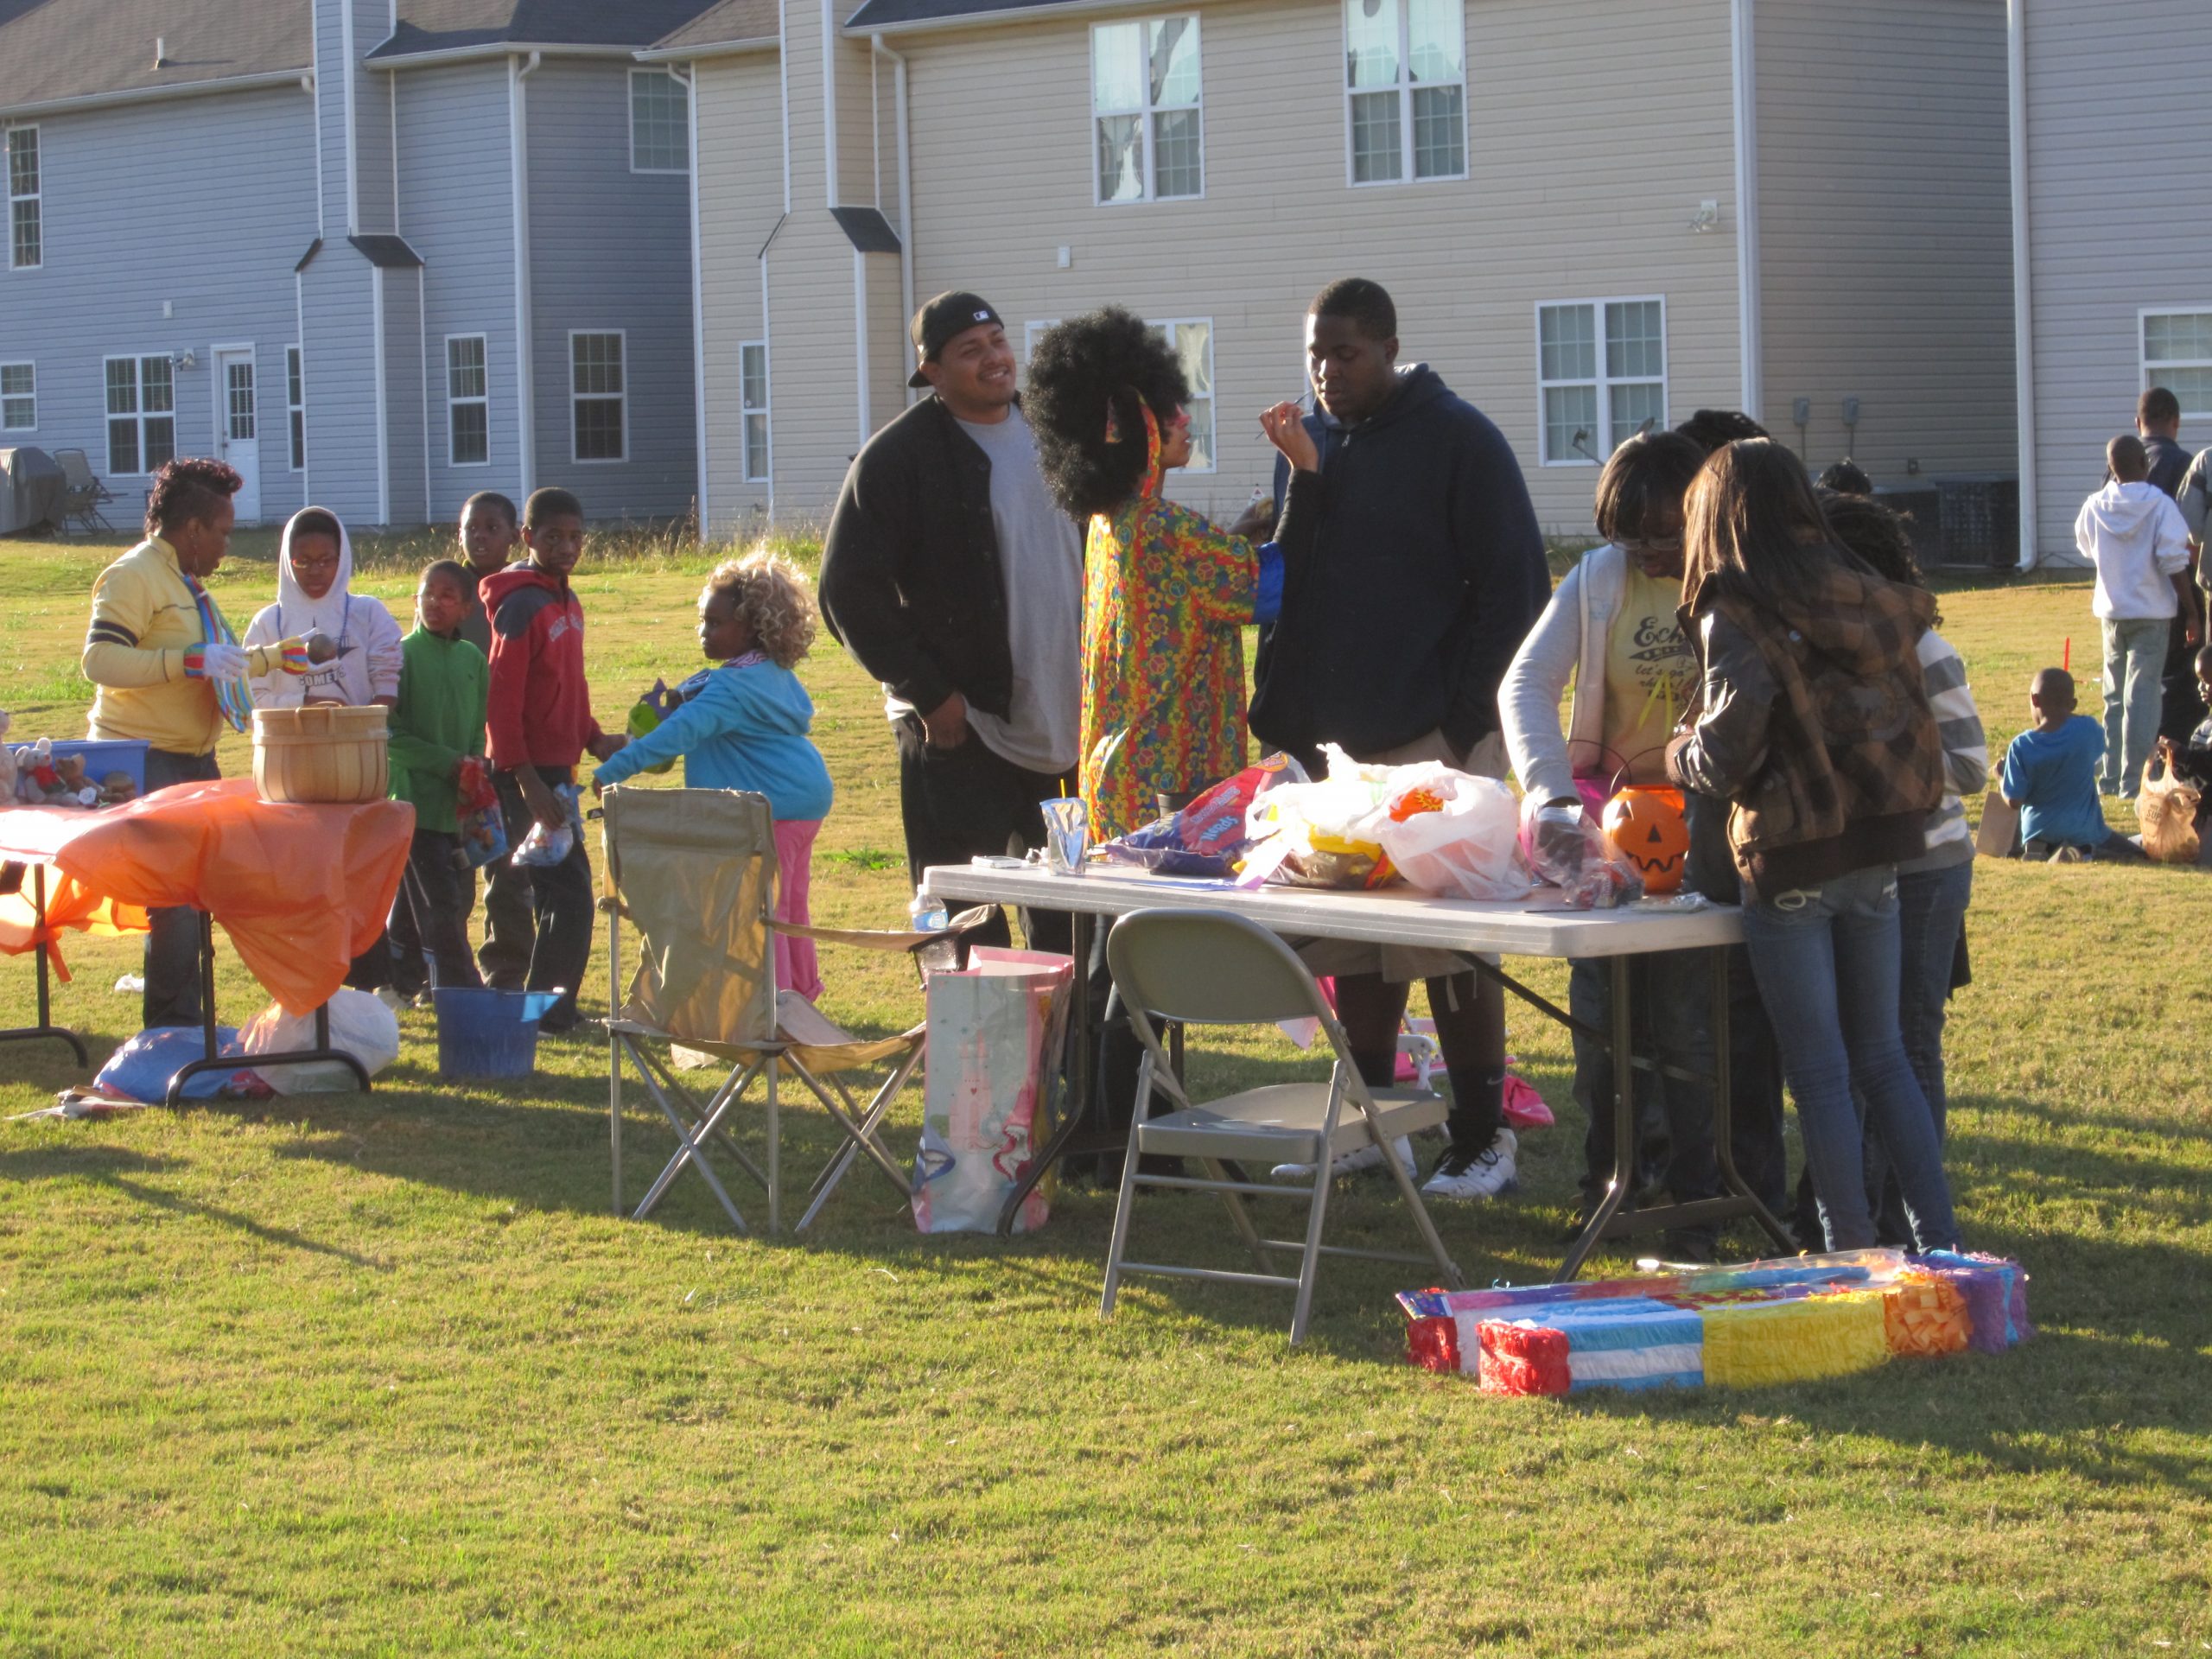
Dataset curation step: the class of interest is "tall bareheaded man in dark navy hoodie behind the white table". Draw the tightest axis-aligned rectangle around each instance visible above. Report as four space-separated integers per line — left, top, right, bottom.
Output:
1252 276 1551 1199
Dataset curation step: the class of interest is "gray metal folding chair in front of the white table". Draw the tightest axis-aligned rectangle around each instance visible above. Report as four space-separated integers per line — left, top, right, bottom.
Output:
1099 909 1460 1343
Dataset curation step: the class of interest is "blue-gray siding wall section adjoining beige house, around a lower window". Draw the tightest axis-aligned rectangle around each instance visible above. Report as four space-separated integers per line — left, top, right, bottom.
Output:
524 58 696 518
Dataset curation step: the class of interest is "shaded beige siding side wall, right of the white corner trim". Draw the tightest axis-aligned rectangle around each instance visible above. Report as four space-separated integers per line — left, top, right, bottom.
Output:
1754 0 2018 499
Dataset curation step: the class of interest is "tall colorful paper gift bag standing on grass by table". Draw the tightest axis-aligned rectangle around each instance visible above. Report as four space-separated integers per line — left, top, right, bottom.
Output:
913 947 1075 1232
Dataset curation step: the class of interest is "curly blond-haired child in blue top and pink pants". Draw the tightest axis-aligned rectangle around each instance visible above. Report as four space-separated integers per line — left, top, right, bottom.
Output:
593 550 832 1002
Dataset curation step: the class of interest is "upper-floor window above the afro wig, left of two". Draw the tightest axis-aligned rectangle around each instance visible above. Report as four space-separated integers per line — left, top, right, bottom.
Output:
1090 17 1205 201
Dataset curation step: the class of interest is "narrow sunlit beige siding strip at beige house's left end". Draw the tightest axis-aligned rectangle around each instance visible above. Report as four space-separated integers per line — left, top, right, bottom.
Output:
692 51 783 540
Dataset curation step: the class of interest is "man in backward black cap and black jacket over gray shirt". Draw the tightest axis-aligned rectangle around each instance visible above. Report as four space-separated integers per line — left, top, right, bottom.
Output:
821 292 1082 951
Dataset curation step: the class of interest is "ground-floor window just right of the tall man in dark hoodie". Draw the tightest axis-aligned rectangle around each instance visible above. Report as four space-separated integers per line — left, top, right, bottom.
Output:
1535 299 1666 467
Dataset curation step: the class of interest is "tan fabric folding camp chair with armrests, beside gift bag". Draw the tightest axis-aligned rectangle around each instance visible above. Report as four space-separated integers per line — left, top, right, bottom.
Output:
600 787 988 1232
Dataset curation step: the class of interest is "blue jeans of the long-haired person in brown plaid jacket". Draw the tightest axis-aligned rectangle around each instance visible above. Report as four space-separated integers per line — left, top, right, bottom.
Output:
1743 865 1958 1249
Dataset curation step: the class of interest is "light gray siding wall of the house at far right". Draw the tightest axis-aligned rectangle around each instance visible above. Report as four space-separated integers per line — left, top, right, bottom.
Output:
2026 0 2212 562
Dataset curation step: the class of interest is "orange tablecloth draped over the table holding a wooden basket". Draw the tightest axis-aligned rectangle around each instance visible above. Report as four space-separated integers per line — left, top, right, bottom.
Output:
0 779 414 1013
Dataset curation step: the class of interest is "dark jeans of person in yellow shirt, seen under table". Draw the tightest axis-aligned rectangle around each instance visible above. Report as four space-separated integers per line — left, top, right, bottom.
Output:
1566 951 1721 1204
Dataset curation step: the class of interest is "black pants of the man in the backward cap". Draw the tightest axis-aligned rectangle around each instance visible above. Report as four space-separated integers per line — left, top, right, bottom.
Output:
893 715 1079 967
